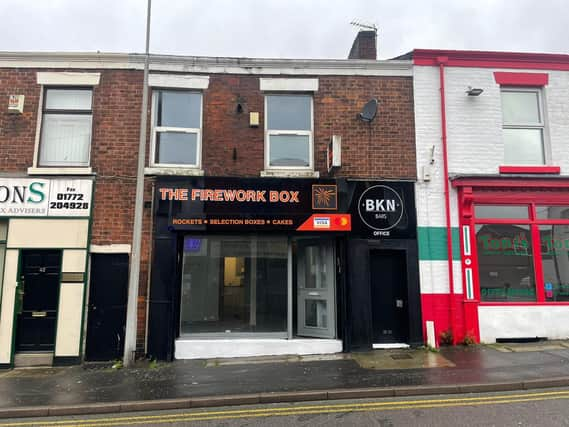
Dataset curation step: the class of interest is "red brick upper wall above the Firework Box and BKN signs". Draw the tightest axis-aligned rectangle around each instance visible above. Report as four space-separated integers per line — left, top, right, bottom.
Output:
202 75 416 179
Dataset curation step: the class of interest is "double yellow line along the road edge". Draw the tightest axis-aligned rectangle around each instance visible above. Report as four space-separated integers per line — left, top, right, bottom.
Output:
0 391 569 427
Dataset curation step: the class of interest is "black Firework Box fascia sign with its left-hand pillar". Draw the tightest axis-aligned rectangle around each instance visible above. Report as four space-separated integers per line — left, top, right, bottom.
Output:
148 177 349 360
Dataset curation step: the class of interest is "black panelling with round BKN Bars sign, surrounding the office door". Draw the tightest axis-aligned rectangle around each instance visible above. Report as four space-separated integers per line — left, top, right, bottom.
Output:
344 181 423 351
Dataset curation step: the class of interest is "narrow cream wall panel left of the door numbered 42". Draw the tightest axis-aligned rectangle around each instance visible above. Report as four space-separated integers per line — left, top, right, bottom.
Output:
0 249 18 363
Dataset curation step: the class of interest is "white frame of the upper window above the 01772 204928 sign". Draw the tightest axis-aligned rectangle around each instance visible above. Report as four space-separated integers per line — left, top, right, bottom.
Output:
36 85 95 169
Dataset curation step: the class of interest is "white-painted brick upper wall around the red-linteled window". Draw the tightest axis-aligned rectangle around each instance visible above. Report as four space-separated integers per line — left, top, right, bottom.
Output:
413 66 569 183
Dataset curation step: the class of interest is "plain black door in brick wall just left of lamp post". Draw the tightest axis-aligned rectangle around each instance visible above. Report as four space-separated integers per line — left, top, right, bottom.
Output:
85 254 128 360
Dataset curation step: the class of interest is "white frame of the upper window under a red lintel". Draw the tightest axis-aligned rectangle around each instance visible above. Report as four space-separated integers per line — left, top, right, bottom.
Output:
500 86 550 167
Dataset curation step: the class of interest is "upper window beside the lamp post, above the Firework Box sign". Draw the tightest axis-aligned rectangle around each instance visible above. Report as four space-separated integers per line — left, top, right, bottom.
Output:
150 89 202 168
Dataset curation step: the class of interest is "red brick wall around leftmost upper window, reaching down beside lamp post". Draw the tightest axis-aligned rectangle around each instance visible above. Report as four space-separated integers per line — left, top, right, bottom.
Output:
0 69 152 350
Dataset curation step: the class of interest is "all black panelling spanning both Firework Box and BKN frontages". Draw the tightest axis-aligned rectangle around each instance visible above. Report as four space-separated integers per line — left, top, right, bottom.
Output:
148 177 422 360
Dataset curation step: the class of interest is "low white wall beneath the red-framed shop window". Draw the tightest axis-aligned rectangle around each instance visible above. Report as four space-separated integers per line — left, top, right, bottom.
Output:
478 305 569 343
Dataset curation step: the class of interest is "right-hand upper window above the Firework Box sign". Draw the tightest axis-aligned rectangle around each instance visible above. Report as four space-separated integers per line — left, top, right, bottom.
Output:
265 94 314 170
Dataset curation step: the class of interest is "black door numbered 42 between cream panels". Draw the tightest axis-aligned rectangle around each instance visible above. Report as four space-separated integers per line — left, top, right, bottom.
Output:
16 249 61 352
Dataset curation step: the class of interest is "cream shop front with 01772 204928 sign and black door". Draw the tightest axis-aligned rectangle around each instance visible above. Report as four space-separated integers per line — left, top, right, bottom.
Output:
0 178 93 367
